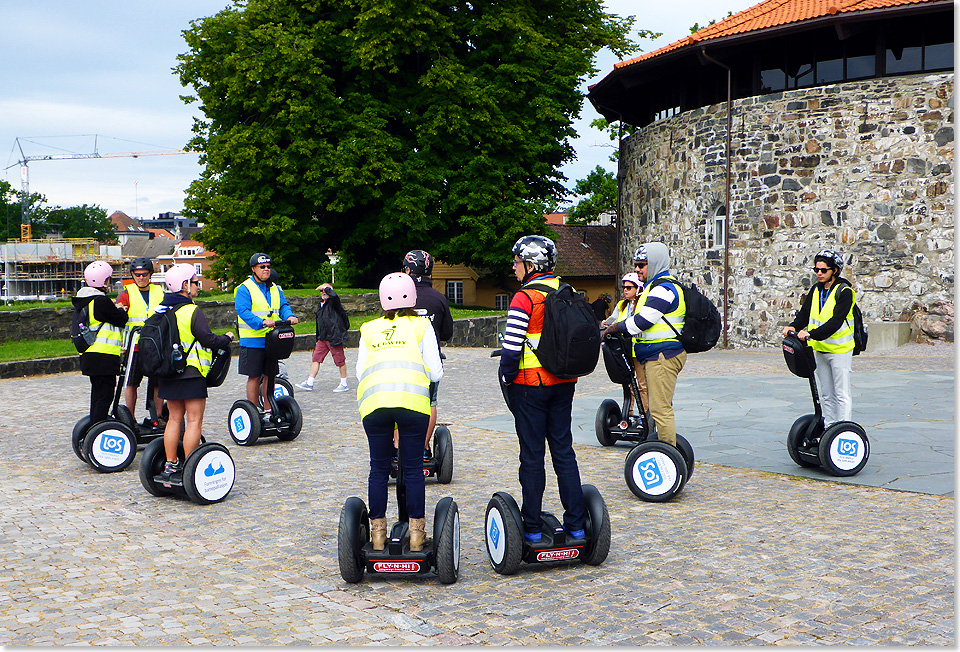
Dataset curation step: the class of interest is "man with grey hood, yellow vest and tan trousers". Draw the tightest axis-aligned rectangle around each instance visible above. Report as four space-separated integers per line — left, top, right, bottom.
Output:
604 242 687 446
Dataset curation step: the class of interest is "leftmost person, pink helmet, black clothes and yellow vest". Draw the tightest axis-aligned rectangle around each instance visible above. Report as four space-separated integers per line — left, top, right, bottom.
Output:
72 260 127 426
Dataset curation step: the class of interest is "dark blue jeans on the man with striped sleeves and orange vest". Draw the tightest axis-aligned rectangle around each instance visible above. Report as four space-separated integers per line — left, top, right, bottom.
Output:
507 383 586 532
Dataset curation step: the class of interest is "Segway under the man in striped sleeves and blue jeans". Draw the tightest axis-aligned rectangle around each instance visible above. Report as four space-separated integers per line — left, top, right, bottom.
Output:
485 484 610 575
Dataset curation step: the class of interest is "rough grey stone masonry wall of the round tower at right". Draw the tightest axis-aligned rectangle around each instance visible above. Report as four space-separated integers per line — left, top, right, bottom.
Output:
620 74 955 347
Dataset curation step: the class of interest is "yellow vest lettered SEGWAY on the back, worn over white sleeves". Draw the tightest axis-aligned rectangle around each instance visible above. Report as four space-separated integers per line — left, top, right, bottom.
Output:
357 317 433 419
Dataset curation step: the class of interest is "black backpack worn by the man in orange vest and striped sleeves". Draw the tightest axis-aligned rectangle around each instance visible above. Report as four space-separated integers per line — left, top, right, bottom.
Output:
524 283 600 379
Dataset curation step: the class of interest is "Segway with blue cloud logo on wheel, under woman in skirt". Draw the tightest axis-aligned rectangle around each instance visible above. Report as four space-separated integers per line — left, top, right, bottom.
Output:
140 439 237 505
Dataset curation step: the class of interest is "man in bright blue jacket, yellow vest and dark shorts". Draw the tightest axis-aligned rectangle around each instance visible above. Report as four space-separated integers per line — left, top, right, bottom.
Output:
233 253 299 411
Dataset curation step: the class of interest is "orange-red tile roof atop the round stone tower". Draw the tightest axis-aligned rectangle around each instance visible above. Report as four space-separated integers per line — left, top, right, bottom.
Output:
614 0 942 70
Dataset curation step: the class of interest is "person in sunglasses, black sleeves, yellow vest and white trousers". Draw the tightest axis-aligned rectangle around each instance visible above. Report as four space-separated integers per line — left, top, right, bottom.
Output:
783 249 857 428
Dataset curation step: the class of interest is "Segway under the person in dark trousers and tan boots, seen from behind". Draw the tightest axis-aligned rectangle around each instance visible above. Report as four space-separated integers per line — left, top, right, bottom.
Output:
337 448 460 584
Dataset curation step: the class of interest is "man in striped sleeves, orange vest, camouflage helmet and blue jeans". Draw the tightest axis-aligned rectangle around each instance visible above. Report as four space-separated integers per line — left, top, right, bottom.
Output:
500 235 586 543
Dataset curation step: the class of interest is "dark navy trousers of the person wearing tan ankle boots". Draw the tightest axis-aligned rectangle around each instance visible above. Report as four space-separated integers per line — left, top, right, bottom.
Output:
363 408 430 518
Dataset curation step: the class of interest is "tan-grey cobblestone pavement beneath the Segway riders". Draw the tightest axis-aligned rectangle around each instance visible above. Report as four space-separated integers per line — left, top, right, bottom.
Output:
0 349 956 646
